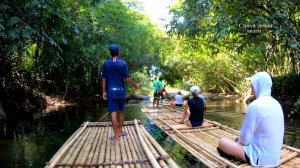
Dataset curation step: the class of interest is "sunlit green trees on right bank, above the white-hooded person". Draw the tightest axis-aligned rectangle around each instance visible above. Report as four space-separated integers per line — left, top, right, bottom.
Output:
163 0 300 92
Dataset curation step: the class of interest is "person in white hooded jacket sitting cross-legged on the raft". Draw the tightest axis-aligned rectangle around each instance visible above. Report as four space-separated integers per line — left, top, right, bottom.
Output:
217 72 284 167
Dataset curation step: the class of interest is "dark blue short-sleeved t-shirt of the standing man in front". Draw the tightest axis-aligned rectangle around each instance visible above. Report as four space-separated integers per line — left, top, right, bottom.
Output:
102 58 129 99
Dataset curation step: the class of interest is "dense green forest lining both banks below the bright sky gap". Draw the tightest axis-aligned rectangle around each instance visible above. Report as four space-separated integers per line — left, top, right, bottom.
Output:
0 0 300 118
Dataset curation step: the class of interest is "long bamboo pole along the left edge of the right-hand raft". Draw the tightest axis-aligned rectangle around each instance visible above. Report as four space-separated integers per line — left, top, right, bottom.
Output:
144 107 238 168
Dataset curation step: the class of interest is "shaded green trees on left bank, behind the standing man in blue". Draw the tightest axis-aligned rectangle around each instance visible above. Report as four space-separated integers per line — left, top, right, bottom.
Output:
0 0 166 98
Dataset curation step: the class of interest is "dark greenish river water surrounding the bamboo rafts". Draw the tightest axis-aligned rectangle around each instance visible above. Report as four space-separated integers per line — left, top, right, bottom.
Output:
0 101 300 168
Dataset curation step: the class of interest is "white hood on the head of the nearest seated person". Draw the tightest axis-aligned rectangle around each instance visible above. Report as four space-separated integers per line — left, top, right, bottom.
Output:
247 72 272 98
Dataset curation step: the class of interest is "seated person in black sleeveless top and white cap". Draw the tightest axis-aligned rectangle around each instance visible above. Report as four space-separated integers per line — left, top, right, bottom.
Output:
179 86 204 127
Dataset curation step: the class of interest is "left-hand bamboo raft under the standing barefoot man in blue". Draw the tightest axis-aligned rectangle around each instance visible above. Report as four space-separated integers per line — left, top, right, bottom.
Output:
45 120 178 168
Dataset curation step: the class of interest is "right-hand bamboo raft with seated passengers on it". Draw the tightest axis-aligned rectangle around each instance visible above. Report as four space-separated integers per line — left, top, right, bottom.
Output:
142 107 300 168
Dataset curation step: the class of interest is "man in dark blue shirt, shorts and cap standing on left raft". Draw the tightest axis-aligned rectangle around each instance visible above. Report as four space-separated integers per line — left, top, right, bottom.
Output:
102 44 140 142
